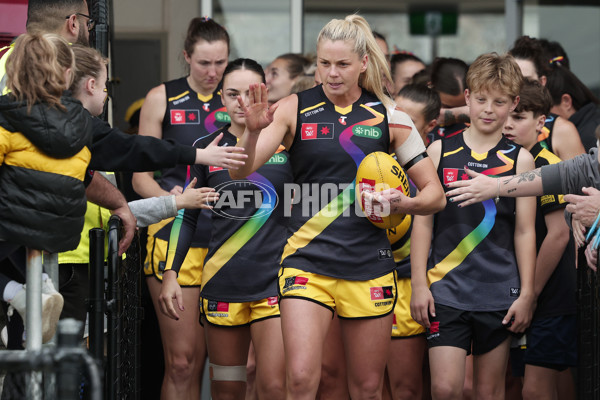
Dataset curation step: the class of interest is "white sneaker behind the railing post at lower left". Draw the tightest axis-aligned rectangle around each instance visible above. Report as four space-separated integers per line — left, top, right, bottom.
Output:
8 279 64 343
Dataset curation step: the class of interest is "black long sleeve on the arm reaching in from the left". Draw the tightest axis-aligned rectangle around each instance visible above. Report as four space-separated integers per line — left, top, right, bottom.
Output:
89 117 196 172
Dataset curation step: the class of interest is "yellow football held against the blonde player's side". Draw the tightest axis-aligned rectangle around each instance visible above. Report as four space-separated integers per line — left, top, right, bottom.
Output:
356 151 410 229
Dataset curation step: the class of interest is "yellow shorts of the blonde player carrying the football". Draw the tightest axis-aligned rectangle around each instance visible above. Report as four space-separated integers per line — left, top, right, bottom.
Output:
279 268 396 319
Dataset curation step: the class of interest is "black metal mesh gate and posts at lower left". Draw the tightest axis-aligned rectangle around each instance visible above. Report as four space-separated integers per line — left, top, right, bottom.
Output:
90 216 143 400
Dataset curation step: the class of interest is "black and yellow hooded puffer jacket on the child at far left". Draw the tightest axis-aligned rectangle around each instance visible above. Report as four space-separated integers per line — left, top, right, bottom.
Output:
0 93 92 253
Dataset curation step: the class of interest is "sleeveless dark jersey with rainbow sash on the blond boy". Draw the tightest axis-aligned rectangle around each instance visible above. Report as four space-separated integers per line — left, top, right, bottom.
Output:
427 133 520 311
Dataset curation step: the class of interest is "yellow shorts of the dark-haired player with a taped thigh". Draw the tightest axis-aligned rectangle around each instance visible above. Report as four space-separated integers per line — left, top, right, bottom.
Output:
200 296 279 326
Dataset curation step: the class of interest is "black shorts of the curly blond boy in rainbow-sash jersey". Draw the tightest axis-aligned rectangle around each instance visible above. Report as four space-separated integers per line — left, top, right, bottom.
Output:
427 303 510 355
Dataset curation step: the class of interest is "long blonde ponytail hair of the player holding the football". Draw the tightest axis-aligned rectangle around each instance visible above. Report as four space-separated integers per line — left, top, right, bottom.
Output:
317 14 394 108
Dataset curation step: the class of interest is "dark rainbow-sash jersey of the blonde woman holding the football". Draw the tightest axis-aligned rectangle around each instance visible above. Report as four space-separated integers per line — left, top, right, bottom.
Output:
282 86 395 280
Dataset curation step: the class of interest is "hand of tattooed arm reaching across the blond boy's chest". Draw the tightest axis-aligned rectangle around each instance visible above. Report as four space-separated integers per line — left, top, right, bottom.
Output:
446 167 498 207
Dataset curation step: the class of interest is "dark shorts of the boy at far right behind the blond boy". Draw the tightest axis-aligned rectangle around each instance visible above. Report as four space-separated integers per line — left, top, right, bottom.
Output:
524 315 577 371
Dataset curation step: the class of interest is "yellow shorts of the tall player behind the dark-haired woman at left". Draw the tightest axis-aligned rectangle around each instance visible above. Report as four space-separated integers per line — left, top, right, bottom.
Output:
144 218 208 286
